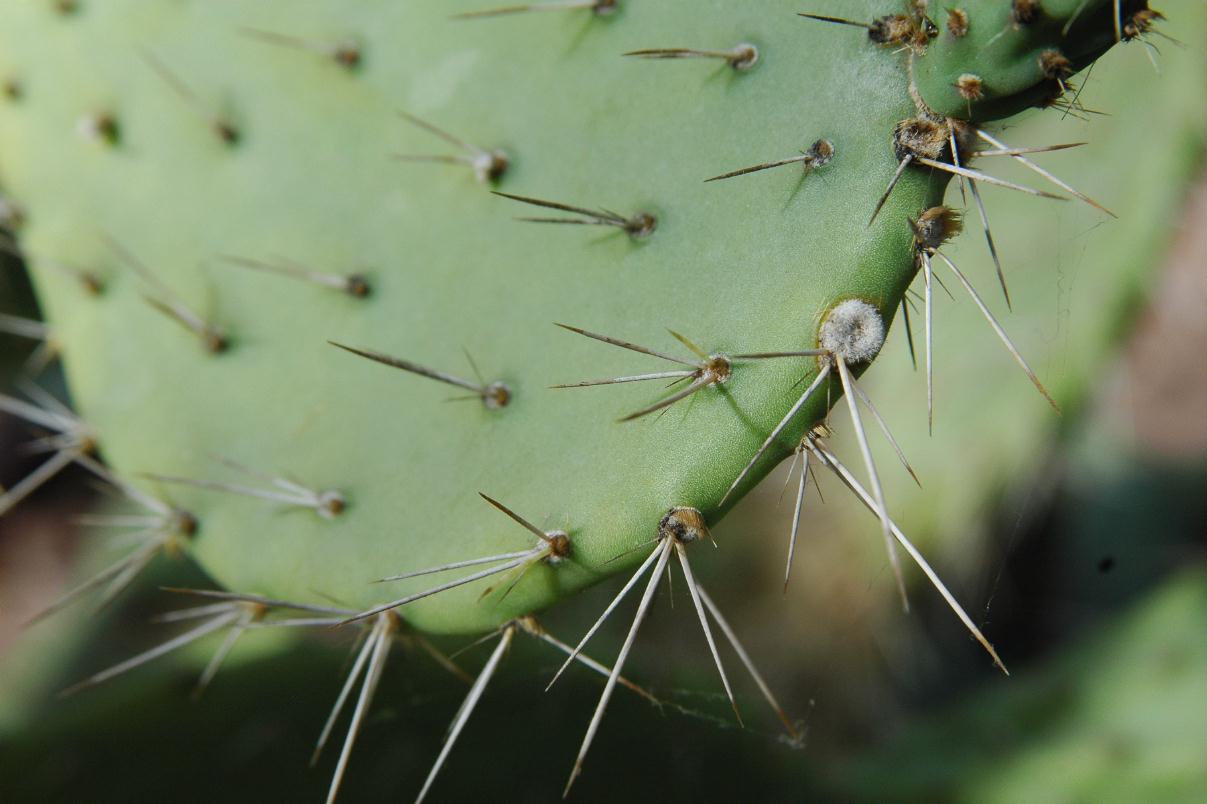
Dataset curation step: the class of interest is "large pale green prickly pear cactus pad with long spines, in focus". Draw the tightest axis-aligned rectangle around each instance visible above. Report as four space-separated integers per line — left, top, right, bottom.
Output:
0 0 1160 796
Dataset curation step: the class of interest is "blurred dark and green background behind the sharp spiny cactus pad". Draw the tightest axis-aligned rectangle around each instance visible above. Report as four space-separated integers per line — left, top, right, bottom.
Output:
0 12 1207 802
